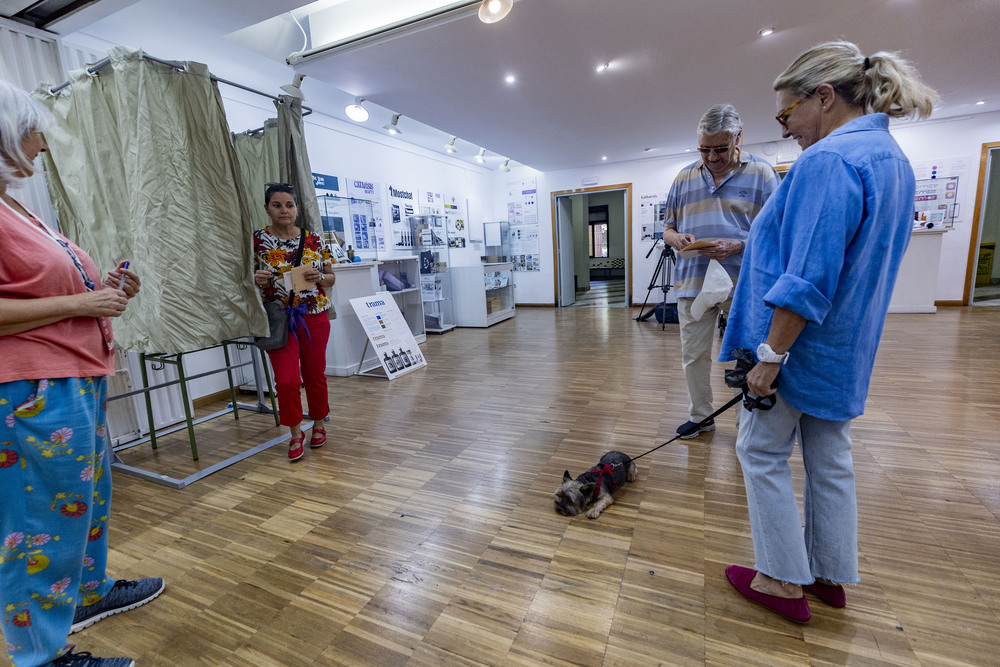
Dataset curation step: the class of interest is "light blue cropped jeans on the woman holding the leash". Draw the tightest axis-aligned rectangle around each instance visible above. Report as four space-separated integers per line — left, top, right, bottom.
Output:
736 392 860 585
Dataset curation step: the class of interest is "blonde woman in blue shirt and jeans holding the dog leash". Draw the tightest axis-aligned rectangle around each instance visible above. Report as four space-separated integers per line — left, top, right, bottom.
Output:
720 42 937 623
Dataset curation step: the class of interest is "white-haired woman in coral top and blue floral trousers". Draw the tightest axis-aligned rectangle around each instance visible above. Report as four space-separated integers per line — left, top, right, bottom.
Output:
0 82 163 667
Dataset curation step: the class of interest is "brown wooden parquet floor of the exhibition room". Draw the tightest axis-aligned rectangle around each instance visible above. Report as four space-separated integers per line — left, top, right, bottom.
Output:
9 308 1000 667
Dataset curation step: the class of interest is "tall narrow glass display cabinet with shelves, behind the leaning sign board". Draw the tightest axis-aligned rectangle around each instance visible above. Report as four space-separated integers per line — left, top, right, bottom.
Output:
409 215 455 333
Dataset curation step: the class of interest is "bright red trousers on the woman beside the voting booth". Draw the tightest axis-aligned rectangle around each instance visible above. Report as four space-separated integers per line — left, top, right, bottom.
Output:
267 311 330 426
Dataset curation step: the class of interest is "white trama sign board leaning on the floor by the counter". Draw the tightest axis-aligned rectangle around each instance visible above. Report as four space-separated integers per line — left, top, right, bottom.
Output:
351 292 427 380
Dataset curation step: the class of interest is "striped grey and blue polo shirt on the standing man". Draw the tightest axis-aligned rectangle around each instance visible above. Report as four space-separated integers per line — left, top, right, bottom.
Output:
665 153 778 298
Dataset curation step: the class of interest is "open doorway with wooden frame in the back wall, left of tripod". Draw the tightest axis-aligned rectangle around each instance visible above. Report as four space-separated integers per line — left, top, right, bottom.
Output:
552 183 632 308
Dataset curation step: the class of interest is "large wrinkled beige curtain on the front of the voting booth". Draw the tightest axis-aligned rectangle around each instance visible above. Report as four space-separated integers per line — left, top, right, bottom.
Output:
36 47 267 353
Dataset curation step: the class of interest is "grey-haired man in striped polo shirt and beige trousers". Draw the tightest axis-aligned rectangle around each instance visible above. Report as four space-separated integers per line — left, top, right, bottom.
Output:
663 104 778 440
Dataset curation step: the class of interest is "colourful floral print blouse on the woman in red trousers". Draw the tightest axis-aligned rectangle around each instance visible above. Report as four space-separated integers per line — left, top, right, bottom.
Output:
253 228 333 315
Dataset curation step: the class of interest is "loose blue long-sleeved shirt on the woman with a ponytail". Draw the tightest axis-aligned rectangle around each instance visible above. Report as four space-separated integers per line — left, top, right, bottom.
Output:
719 113 916 421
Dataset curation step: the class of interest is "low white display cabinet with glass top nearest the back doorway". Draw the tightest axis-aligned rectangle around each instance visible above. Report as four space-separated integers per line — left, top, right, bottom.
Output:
452 262 514 327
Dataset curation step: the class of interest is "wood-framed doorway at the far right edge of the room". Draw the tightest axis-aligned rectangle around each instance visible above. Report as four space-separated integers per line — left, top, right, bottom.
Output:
965 142 1000 306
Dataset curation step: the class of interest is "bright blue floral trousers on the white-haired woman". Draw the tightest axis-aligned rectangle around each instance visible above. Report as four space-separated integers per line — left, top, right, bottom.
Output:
0 377 114 667
